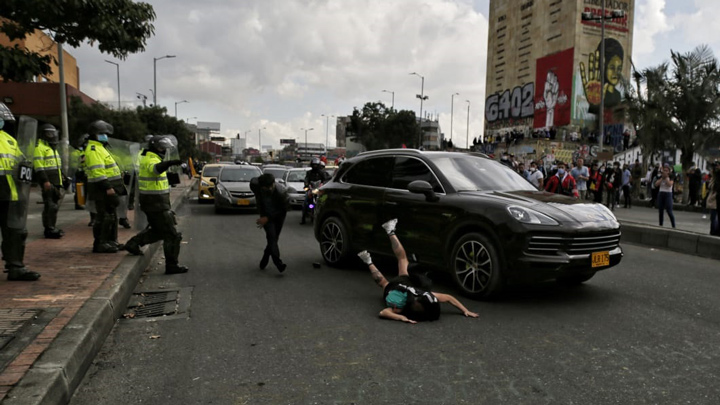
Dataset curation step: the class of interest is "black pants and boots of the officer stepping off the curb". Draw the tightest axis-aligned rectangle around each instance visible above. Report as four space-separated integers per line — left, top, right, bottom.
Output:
127 211 182 267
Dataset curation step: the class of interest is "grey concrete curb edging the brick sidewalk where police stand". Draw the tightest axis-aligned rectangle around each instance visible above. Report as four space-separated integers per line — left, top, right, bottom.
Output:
3 179 197 405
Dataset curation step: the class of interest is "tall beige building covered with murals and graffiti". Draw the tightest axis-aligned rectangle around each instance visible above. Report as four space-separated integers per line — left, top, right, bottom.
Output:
485 0 635 140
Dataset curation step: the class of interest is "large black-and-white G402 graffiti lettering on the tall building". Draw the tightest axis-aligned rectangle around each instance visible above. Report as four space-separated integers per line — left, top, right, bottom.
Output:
485 83 535 124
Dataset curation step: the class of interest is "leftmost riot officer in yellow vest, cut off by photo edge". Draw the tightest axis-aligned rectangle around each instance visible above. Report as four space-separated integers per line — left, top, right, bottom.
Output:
0 103 40 281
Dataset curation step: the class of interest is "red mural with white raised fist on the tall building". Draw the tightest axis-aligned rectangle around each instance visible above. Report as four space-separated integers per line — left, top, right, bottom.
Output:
533 48 574 129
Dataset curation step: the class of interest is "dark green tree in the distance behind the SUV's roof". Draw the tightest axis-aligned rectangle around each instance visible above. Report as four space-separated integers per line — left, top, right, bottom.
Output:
346 103 419 150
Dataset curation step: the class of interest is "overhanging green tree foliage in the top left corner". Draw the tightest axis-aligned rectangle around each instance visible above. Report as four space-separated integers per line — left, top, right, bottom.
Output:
0 0 155 82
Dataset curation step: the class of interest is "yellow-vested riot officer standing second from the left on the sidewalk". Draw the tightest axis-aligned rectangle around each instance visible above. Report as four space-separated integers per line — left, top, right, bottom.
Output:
33 124 65 239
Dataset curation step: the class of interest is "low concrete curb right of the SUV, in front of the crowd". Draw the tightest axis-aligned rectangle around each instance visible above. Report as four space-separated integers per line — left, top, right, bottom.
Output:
620 221 720 259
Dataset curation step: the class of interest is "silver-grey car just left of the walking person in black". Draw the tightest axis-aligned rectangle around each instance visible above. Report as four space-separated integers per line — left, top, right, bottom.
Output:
215 165 262 212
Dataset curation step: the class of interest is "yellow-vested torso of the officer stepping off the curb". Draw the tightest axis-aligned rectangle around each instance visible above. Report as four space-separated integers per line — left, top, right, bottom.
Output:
138 150 170 212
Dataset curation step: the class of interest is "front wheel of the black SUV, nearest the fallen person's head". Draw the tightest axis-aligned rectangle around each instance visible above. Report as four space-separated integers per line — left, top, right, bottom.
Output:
450 233 502 299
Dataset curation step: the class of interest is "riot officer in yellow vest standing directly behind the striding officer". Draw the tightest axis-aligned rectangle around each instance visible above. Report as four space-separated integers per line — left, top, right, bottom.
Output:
84 120 127 253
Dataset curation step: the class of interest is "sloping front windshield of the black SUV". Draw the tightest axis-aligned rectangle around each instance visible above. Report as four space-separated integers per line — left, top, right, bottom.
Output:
431 155 537 192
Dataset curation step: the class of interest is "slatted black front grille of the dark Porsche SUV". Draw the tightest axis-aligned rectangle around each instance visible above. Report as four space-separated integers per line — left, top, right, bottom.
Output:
527 231 621 256
